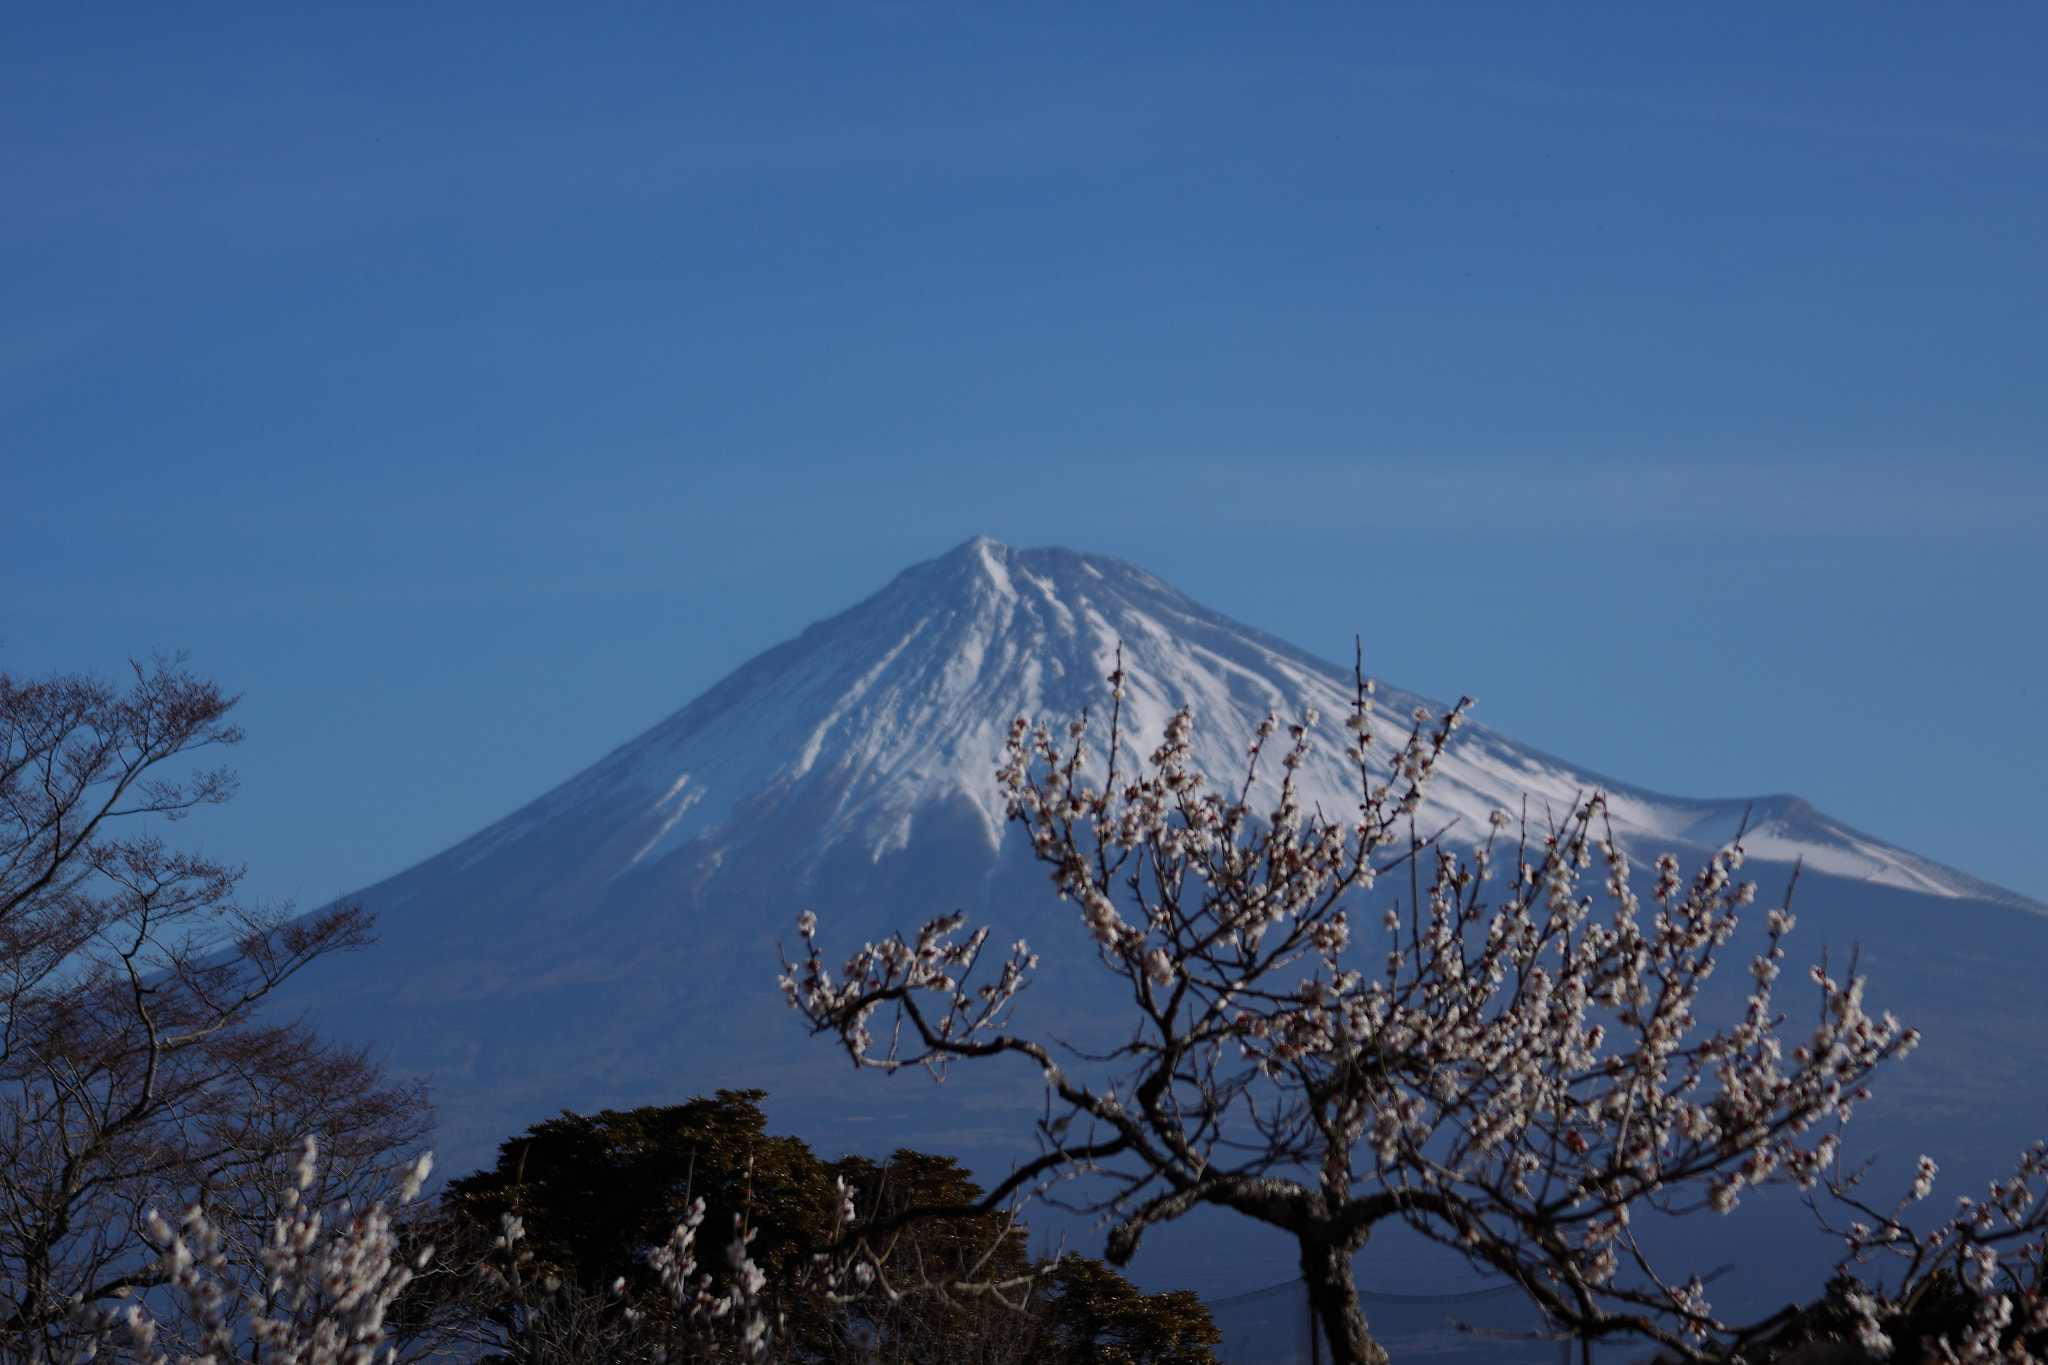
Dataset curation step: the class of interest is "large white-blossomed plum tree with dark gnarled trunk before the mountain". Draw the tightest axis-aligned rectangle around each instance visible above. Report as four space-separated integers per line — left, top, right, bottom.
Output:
782 661 1915 1365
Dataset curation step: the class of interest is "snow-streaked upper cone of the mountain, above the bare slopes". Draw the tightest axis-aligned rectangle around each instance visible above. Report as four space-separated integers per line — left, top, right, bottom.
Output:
419 538 2017 916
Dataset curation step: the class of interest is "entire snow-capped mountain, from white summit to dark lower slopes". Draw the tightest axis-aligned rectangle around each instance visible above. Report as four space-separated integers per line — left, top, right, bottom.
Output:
276 540 2048 1326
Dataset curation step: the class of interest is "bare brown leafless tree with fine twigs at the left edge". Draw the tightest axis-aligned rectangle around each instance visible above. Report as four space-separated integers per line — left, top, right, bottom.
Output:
0 659 428 1357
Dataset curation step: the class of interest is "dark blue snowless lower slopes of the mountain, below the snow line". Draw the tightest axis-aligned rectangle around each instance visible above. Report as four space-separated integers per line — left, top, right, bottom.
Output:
291 819 2048 1169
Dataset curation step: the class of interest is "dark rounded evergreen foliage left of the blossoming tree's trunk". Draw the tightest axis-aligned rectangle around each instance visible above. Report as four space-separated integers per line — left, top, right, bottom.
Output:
436 1091 1221 1365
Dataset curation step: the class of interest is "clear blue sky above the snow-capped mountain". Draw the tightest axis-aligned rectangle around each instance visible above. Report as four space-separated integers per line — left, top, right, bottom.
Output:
0 10 2048 902
